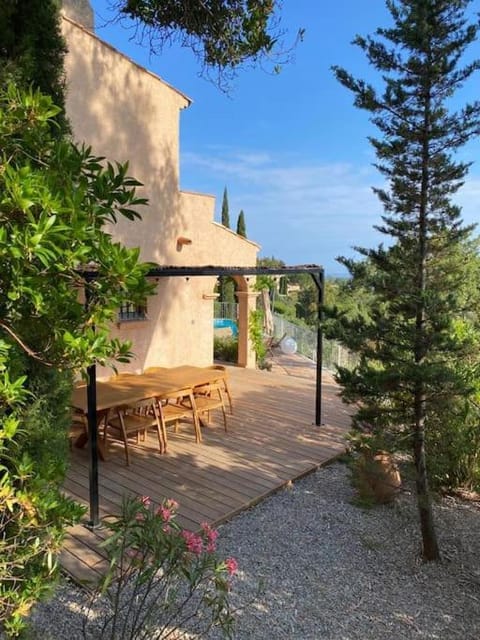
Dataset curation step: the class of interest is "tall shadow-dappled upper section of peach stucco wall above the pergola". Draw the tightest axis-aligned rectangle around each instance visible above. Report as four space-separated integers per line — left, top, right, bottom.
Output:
63 18 189 260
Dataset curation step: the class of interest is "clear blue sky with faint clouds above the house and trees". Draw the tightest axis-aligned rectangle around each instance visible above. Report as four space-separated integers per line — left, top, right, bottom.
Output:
91 0 480 275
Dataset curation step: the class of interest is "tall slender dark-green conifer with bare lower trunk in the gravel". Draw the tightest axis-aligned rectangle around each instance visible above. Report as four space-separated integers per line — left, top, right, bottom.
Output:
334 0 480 560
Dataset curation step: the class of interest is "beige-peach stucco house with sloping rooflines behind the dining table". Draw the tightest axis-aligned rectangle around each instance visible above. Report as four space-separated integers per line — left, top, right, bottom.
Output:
62 9 259 377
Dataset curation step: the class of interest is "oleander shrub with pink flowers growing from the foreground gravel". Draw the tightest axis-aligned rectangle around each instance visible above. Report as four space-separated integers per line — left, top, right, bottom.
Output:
84 496 237 640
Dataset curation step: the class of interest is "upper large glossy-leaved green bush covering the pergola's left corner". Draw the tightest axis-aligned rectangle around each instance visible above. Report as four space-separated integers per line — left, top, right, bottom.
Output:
0 85 152 368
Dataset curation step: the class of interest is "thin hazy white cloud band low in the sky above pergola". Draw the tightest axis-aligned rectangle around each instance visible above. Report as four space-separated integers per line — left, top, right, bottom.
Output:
182 148 480 272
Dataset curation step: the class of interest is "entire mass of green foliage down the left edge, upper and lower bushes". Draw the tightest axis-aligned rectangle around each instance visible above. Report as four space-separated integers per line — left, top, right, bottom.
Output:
0 85 156 635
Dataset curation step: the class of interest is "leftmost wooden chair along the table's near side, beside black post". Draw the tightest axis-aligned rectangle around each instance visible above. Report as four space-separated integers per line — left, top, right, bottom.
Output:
103 401 166 466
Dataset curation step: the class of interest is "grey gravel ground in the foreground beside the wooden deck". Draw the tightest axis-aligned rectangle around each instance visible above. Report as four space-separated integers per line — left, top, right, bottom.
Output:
25 463 480 640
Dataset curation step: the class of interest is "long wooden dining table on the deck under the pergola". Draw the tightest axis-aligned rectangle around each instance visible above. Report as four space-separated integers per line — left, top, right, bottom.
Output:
71 365 226 459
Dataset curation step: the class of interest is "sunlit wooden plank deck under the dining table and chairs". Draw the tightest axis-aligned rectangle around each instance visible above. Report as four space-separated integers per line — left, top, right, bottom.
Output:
61 360 349 584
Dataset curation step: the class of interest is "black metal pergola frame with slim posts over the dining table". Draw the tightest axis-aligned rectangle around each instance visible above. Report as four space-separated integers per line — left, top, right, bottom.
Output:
82 264 325 528
